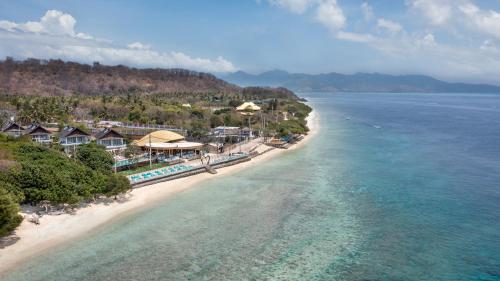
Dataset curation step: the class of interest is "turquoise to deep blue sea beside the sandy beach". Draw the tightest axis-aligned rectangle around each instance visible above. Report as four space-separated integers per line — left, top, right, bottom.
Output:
4 93 500 281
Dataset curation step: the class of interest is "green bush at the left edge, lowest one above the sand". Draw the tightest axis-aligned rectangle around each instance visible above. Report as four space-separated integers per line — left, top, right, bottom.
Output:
0 186 23 237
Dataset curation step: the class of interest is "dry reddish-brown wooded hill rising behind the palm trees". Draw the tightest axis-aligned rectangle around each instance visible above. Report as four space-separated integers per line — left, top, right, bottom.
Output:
0 58 296 98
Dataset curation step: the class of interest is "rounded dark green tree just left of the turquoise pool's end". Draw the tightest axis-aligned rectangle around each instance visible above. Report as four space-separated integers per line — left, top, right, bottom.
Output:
75 143 113 174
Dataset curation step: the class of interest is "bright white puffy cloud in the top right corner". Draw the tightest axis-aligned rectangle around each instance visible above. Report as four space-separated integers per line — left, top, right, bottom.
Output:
459 3 500 38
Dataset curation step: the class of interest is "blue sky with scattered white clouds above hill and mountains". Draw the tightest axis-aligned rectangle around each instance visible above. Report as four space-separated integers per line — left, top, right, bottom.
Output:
0 0 500 84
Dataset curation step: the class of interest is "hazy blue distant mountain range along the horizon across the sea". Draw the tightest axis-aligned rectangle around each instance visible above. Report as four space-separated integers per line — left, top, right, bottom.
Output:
221 70 500 93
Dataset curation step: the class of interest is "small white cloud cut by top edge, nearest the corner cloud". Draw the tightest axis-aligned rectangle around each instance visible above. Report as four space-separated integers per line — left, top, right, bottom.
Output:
407 0 453 26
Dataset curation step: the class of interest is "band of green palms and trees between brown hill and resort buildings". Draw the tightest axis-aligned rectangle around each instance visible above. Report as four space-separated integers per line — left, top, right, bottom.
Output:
0 93 311 139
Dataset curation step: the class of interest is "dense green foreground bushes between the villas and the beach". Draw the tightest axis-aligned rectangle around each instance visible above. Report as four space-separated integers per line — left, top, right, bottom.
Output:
0 135 130 236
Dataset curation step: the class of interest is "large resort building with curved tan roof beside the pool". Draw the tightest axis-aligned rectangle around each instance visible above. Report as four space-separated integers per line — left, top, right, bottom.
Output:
132 130 203 158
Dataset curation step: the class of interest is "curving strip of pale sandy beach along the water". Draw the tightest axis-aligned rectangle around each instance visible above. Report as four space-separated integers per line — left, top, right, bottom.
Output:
0 110 319 276
